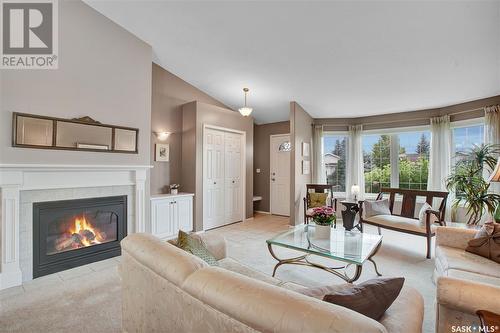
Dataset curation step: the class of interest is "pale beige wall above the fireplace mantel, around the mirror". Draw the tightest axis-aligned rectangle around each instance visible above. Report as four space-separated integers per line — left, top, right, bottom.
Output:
0 1 151 165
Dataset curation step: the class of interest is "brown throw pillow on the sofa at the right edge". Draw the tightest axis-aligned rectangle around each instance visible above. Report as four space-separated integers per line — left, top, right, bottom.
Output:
465 222 500 264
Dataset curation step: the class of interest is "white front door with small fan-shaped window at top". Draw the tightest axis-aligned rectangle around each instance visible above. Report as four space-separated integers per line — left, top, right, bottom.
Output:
269 134 291 216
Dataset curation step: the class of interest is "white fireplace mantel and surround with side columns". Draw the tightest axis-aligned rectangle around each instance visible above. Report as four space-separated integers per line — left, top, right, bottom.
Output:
0 164 151 290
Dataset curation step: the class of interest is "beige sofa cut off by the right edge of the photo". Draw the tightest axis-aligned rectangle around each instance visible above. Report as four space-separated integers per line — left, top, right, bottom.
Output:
434 227 500 333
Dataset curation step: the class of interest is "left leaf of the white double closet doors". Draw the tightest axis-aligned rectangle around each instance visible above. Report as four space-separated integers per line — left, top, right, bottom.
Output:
203 129 225 229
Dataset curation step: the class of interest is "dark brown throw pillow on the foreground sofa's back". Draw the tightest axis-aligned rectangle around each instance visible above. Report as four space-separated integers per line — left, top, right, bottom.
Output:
323 277 405 320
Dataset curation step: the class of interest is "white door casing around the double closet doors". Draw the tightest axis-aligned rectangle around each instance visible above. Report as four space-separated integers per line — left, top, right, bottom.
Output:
201 124 245 230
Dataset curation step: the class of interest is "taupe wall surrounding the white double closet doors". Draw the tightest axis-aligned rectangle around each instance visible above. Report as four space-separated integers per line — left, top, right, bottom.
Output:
181 102 253 231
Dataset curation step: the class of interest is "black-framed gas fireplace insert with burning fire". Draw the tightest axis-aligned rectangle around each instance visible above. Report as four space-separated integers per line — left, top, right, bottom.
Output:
33 196 127 278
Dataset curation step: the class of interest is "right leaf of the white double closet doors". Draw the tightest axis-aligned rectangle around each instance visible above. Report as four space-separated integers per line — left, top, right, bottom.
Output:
225 132 243 223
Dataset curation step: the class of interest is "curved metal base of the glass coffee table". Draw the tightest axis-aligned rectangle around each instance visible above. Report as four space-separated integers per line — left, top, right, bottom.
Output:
267 242 382 283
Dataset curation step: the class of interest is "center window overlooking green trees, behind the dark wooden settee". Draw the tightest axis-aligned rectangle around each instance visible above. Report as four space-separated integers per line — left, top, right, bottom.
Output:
363 130 430 193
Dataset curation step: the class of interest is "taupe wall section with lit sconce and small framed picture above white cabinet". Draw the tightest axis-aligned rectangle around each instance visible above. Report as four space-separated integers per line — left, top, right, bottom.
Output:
150 64 225 194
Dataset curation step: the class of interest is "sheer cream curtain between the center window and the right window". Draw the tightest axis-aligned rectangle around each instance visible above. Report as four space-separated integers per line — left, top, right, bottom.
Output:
427 115 454 221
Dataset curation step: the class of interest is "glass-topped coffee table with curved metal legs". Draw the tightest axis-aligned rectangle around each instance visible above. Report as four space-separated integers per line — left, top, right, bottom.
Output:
266 224 382 283
